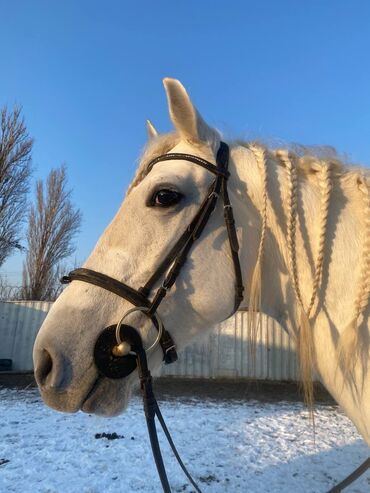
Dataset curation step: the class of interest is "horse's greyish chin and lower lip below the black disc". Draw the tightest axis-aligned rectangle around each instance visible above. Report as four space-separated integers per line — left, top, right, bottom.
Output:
81 377 132 417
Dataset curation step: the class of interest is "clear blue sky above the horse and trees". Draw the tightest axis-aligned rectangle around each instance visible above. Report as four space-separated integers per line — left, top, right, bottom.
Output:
0 0 370 279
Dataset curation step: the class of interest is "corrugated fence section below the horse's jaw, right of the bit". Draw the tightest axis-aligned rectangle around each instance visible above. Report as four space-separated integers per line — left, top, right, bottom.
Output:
161 312 299 381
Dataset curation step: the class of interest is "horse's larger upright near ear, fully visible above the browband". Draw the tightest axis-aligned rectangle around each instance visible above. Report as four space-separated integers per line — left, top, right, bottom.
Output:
163 77 219 145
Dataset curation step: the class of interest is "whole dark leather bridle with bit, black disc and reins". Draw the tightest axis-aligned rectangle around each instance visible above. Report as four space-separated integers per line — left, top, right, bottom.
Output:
61 142 370 493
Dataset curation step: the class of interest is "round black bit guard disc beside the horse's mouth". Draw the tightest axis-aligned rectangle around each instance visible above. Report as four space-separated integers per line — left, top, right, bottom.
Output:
94 325 142 379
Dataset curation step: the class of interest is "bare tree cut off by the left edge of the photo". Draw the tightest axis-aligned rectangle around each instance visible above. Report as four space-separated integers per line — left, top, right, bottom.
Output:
0 107 33 266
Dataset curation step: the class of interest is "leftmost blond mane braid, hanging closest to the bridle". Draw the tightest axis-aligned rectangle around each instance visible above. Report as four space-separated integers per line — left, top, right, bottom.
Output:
248 145 267 358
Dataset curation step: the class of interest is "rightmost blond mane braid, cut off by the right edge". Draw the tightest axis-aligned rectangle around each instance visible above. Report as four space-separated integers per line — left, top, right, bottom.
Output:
338 174 370 372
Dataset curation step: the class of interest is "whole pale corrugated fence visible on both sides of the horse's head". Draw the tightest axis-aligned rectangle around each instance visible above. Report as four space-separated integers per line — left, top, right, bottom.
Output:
0 301 298 380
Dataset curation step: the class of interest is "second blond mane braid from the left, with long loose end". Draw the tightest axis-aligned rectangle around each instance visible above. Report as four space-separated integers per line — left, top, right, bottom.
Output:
276 150 314 412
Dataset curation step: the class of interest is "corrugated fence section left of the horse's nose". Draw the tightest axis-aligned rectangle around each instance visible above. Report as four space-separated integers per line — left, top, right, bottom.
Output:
0 301 52 371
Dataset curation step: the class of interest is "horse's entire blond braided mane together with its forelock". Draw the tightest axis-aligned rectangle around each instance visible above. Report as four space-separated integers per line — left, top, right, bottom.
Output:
127 133 370 408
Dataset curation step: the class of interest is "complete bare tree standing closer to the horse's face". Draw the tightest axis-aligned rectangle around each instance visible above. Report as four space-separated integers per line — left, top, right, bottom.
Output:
22 165 81 300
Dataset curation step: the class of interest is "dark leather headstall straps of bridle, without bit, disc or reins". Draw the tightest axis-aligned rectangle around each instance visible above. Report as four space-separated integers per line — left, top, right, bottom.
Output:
62 142 244 364
